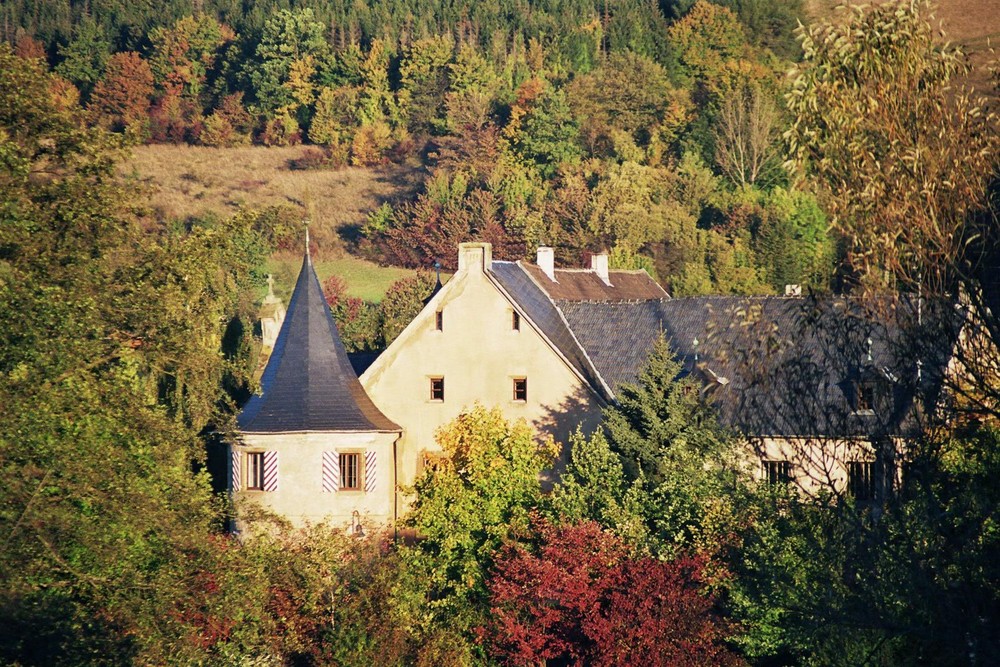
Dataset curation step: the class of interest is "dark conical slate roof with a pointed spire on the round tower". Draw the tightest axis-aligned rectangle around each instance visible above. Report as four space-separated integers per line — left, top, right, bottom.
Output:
237 255 400 433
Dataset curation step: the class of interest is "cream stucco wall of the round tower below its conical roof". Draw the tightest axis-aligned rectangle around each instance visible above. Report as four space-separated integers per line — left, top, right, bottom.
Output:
229 432 398 530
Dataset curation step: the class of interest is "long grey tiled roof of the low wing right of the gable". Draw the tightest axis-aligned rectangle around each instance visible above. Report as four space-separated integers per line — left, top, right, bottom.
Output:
558 297 955 436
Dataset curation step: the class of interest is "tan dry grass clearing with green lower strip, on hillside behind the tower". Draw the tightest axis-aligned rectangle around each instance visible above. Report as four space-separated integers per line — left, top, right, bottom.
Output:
123 145 424 301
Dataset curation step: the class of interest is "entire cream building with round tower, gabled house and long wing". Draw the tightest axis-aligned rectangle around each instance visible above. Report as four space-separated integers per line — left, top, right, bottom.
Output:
231 243 956 522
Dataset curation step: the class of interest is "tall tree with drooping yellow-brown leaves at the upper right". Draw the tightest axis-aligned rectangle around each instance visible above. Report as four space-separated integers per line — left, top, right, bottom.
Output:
787 1 998 292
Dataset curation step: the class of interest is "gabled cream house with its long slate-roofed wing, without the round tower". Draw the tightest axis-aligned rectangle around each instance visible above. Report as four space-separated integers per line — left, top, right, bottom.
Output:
361 244 954 512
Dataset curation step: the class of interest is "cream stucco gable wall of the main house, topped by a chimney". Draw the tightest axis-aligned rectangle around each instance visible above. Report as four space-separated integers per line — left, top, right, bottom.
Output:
360 244 601 498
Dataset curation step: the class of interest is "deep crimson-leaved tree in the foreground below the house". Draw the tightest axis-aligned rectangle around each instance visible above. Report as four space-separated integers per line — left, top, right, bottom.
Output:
480 522 740 667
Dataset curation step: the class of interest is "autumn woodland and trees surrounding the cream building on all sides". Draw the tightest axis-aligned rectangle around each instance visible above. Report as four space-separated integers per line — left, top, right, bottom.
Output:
0 0 1000 665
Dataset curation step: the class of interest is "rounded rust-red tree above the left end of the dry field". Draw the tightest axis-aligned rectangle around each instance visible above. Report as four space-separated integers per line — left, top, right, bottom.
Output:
90 51 153 130
